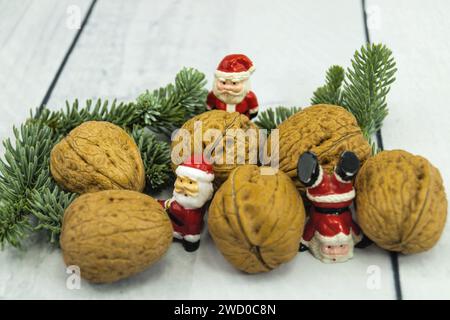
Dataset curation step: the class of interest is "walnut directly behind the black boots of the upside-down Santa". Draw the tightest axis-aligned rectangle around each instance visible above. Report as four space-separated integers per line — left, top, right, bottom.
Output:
268 104 371 192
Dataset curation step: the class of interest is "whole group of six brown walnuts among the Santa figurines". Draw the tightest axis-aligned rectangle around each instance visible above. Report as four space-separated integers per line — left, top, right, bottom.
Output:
50 105 447 283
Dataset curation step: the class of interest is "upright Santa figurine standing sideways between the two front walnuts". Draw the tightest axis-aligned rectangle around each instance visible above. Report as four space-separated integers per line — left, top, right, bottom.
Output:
159 156 214 252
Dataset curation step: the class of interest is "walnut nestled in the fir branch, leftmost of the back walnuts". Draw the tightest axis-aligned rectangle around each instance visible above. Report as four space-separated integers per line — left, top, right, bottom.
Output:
50 121 145 193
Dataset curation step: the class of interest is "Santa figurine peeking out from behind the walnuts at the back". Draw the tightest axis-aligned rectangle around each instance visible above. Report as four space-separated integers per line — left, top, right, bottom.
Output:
206 54 258 119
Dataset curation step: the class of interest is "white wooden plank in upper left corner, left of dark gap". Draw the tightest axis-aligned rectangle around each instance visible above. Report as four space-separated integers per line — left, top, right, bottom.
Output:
0 0 90 154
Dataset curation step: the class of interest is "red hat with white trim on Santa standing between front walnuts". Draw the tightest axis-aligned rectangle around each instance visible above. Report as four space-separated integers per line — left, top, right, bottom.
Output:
175 155 214 182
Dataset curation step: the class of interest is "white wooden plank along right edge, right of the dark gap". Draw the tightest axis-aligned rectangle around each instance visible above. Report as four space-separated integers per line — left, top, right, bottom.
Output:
368 0 450 299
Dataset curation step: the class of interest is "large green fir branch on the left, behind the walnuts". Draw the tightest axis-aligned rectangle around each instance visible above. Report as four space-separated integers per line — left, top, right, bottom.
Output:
0 68 207 248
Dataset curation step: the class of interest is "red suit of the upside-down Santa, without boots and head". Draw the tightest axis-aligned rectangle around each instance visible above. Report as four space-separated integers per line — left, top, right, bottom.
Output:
303 172 361 241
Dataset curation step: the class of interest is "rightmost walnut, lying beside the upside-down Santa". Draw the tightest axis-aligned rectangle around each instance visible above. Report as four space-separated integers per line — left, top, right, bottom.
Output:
356 150 447 254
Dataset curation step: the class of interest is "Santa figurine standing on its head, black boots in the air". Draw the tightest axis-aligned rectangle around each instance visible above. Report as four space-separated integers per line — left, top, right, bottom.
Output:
297 151 362 263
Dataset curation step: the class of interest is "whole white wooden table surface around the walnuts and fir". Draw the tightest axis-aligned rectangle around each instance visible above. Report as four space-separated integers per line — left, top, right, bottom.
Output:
0 0 450 299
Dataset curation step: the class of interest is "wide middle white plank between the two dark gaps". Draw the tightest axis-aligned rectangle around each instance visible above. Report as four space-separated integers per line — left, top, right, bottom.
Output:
0 0 395 299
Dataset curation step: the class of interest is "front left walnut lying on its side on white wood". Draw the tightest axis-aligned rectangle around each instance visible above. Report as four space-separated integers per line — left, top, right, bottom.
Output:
60 190 172 283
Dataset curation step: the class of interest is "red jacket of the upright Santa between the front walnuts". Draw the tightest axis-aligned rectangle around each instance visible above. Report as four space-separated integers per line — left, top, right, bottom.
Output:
159 199 205 236
